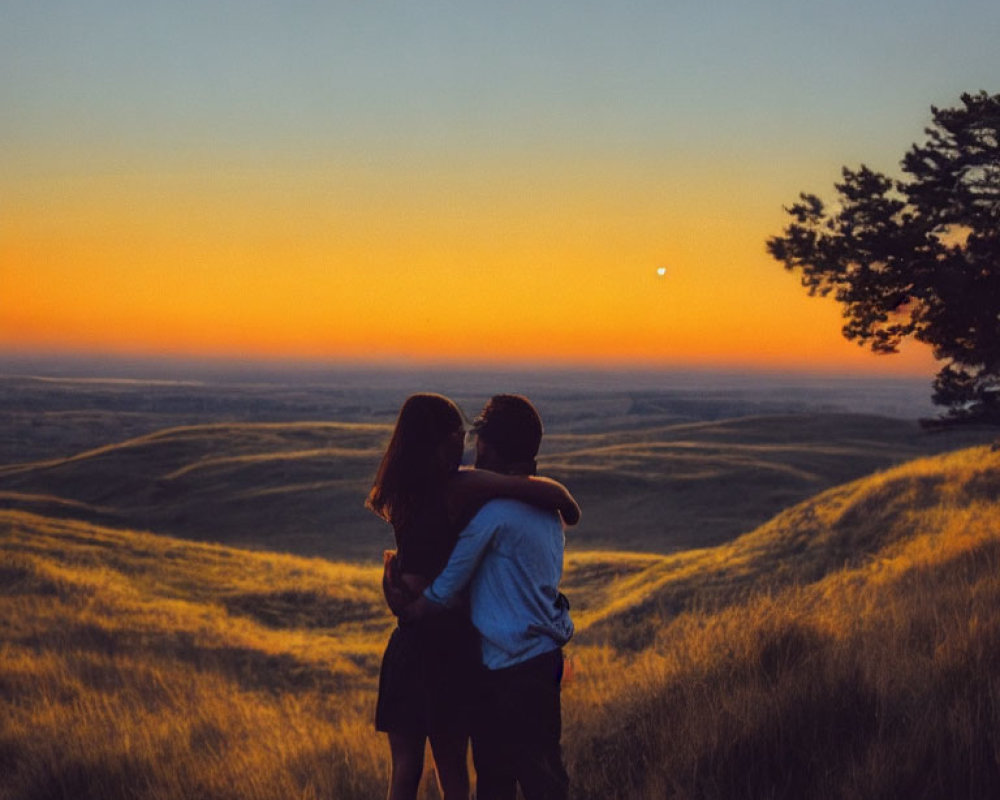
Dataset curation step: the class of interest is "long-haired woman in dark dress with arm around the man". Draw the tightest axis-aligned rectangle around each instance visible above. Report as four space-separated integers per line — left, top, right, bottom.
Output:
366 394 580 800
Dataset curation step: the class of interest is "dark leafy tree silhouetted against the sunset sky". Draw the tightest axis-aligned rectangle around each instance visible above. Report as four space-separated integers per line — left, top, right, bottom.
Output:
767 91 1000 422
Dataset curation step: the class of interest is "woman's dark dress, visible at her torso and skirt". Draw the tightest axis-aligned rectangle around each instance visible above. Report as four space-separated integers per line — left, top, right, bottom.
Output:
375 498 481 735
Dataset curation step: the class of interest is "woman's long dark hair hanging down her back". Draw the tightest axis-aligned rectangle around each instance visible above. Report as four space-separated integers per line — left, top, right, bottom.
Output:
365 394 464 527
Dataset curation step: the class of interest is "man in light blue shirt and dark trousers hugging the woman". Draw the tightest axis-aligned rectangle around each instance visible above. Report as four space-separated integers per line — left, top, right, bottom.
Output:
406 395 573 800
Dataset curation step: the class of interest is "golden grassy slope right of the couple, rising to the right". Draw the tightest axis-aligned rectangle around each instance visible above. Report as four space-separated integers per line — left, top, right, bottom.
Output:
565 448 1000 800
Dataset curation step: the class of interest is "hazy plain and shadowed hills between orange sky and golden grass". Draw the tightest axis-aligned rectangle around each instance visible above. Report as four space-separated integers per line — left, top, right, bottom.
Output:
0 361 991 562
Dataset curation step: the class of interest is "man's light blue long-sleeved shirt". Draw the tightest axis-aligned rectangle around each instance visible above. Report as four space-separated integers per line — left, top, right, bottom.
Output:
424 499 573 669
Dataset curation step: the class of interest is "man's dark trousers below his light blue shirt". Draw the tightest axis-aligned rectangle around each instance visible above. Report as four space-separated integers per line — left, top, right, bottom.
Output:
472 648 569 800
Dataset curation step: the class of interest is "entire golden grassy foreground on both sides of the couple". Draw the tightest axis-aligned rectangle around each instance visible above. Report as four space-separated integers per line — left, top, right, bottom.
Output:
0 447 1000 800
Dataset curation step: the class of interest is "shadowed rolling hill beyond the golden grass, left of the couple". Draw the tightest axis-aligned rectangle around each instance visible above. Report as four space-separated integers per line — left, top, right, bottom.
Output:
0 422 391 561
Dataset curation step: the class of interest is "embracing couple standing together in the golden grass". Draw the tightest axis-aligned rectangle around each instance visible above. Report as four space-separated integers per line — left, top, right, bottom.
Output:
367 394 580 800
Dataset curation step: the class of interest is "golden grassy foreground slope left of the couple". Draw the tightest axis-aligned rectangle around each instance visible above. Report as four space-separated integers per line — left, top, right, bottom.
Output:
0 512 391 800
